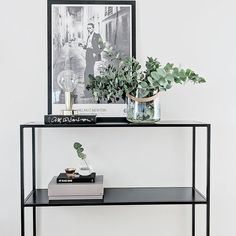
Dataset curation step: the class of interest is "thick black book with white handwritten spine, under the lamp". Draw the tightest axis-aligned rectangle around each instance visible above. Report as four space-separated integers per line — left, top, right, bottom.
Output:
44 114 96 125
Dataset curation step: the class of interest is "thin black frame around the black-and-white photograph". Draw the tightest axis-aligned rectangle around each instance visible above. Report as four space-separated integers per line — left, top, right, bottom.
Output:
47 0 136 122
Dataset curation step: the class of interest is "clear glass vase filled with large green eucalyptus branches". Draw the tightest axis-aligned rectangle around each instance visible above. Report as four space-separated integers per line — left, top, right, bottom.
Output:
88 56 205 123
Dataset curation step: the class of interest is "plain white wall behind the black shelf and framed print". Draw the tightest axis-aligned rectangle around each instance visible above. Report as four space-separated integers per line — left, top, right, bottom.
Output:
0 0 236 236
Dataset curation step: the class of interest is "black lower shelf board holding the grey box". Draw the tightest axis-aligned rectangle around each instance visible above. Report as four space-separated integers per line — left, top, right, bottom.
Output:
24 187 207 207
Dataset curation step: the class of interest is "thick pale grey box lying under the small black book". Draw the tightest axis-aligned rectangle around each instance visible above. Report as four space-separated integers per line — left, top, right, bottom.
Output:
48 175 104 197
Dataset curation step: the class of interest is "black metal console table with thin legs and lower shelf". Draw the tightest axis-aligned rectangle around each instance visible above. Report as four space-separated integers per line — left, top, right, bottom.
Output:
20 121 211 236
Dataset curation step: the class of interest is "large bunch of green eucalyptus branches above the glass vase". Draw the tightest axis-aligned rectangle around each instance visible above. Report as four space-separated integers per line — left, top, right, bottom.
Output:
87 56 206 103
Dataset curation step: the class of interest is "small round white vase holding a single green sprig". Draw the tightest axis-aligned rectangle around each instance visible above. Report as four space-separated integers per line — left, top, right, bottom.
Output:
74 142 92 176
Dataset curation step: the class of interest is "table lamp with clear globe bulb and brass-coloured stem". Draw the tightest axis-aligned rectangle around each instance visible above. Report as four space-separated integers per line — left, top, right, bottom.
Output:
57 70 79 115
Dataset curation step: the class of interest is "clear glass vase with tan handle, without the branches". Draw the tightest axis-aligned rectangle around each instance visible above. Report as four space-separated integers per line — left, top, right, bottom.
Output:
127 93 161 123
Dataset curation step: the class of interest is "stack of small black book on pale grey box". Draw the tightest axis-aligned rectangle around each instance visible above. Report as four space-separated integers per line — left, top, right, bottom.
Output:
48 173 104 200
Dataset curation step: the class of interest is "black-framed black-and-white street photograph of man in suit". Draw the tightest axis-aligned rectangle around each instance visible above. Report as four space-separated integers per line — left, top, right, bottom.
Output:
48 0 136 118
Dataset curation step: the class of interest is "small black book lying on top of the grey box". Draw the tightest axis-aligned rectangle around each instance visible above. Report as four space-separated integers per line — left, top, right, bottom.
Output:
57 172 96 184
